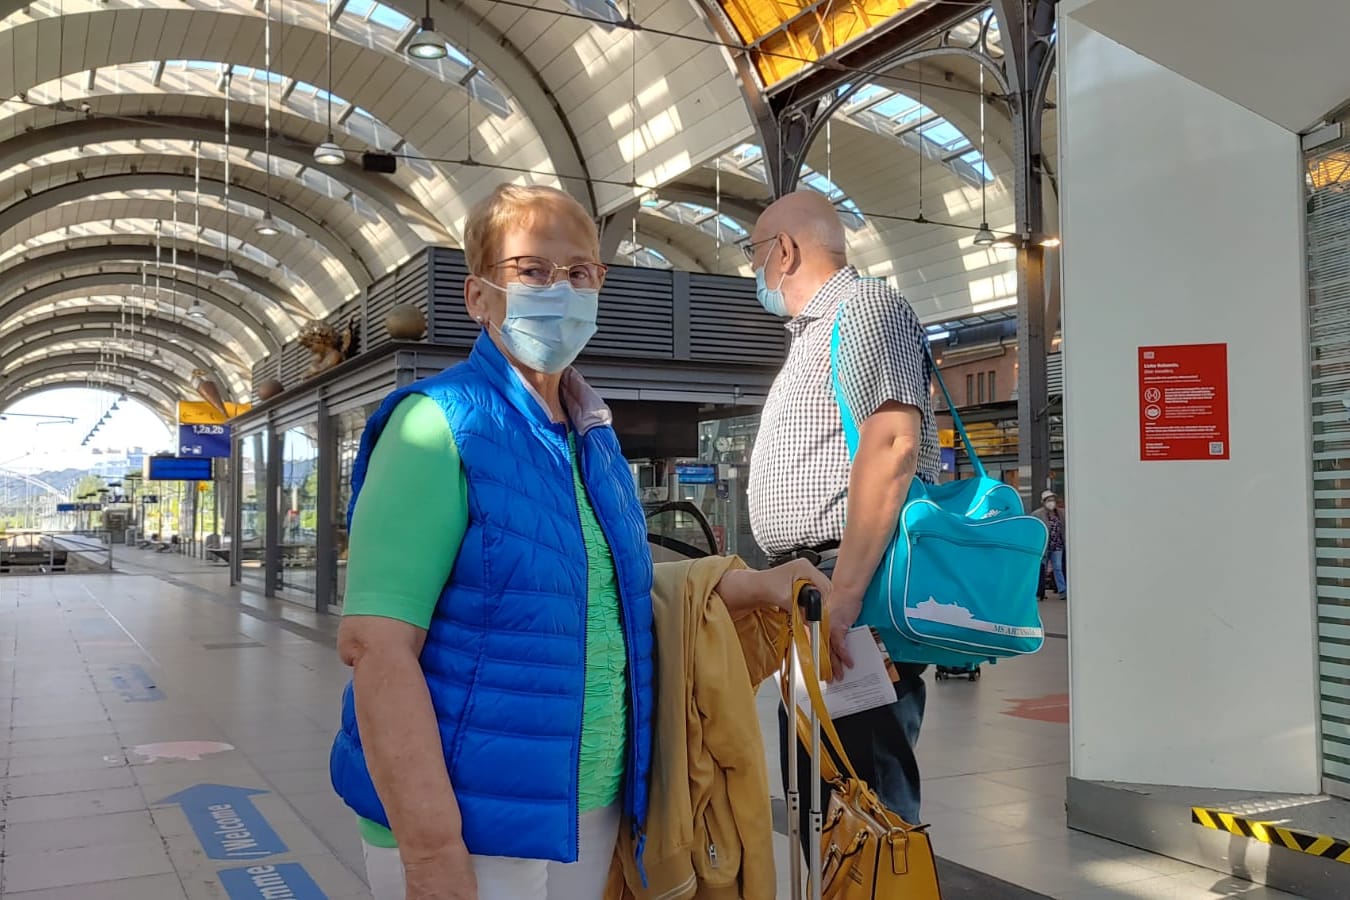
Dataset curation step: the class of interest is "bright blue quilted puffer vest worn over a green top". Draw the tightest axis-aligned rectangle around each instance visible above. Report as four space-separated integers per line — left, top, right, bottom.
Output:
329 336 652 862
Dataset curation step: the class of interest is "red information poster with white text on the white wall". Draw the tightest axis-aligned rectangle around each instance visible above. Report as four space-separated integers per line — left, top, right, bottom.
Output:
1139 344 1229 461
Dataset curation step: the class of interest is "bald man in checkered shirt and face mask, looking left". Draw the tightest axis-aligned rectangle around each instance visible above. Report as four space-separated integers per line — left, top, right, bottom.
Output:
744 190 940 835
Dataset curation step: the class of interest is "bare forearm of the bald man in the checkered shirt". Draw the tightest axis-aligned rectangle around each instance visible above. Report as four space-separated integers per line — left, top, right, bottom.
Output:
833 441 917 602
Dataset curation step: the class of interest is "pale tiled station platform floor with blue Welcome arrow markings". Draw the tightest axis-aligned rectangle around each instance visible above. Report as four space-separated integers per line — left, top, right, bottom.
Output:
0 551 1293 900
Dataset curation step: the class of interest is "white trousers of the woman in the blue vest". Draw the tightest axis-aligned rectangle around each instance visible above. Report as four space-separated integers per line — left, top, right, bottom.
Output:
365 803 621 900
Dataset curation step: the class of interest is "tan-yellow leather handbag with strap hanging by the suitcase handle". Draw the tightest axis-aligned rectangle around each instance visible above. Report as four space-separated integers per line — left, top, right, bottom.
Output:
783 603 942 900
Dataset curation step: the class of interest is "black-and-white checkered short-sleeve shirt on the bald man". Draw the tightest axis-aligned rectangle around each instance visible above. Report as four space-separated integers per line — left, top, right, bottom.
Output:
748 266 941 556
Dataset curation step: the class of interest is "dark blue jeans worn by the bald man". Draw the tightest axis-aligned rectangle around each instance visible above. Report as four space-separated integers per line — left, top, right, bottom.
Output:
778 560 927 849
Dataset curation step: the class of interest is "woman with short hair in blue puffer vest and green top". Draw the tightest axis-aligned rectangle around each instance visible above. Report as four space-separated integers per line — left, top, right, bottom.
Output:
331 186 826 900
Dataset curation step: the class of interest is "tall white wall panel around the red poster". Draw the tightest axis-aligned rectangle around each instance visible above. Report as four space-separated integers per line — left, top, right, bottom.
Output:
1058 12 1320 792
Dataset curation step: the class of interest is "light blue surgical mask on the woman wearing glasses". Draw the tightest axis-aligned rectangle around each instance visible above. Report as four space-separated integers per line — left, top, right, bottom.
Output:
486 281 599 375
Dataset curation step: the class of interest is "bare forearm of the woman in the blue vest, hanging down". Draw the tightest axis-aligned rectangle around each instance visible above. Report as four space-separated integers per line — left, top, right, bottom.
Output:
352 649 463 864
